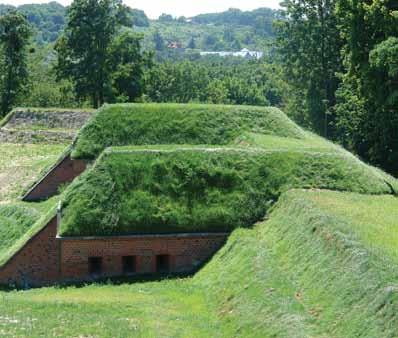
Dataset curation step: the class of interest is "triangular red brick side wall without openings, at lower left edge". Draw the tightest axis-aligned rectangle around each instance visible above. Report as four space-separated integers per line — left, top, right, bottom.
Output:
0 218 59 286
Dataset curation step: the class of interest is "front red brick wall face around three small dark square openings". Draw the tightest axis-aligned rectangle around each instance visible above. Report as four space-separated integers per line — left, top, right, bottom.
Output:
60 234 227 280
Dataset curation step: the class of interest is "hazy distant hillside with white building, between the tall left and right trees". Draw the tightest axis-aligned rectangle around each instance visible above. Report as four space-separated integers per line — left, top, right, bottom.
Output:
141 8 279 51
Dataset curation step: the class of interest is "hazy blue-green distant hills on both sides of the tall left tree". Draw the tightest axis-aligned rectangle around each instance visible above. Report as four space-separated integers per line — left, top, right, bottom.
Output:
0 2 279 52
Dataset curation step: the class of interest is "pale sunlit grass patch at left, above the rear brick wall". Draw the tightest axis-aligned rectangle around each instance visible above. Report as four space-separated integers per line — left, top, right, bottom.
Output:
0 143 67 202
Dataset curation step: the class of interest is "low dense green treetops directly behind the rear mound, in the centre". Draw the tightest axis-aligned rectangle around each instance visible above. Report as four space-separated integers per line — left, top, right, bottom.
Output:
146 56 286 106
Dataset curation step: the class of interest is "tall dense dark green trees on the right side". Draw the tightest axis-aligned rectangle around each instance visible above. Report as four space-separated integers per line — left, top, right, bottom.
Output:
275 0 398 175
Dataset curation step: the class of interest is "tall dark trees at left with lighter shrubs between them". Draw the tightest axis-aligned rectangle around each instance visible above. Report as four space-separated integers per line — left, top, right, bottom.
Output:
0 0 151 112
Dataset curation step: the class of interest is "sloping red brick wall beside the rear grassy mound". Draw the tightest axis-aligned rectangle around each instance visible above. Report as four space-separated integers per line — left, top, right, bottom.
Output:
23 155 86 201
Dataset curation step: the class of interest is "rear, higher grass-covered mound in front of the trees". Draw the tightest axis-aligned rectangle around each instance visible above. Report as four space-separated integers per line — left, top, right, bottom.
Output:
72 104 304 159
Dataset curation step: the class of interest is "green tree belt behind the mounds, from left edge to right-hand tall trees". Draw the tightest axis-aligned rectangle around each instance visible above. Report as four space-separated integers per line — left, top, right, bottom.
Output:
1 0 285 115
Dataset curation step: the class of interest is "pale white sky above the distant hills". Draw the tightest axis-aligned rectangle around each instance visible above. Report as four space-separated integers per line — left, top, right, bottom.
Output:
0 0 281 19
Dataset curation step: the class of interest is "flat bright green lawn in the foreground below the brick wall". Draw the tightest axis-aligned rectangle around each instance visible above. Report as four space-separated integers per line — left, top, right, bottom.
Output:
0 280 224 338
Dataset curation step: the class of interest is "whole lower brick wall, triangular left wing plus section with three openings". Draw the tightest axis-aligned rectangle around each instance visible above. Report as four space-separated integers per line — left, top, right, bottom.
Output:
0 218 227 286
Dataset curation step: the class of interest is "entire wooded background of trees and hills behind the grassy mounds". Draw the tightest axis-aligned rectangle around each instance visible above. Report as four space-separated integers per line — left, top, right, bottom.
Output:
0 0 398 175
